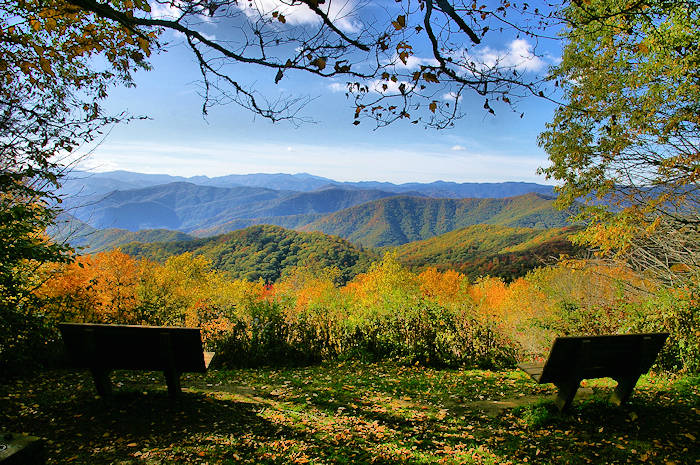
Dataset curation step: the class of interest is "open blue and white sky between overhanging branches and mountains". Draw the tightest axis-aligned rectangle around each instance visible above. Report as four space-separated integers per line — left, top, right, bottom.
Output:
81 0 560 183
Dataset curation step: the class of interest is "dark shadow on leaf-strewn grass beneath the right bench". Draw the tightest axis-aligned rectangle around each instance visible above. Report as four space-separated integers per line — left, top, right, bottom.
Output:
500 392 700 464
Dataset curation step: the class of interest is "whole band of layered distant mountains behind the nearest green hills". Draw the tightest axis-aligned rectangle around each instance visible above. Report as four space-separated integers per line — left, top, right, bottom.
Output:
62 171 566 245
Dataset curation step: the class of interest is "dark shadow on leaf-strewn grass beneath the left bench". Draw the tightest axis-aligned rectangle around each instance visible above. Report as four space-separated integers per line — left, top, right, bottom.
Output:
0 372 422 465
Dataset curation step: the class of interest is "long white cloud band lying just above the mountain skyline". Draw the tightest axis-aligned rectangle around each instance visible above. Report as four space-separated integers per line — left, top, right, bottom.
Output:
83 140 546 183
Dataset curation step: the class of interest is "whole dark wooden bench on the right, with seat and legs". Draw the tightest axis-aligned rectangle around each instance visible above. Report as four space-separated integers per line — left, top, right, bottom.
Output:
518 333 668 411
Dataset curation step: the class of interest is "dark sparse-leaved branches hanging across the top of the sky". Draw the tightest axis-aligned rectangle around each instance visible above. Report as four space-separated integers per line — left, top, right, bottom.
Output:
58 0 558 128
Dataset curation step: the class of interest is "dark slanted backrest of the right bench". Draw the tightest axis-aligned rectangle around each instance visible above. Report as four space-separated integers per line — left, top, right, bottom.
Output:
539 333 668 383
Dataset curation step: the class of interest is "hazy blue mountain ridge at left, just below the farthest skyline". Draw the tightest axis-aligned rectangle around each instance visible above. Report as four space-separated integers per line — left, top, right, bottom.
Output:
64 182 408 234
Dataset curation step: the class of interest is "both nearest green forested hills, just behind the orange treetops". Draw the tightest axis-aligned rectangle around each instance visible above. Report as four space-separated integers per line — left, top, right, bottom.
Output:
115 225 581 282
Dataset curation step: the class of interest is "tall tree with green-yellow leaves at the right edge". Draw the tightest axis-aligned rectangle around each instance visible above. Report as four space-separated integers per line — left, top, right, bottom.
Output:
540 0 700 282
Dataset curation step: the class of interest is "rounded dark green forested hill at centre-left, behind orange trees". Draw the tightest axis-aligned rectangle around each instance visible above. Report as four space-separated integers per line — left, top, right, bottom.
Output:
122 225 376 283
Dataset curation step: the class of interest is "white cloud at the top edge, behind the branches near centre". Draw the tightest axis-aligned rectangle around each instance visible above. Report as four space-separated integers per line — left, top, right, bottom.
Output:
238 0 362 34
